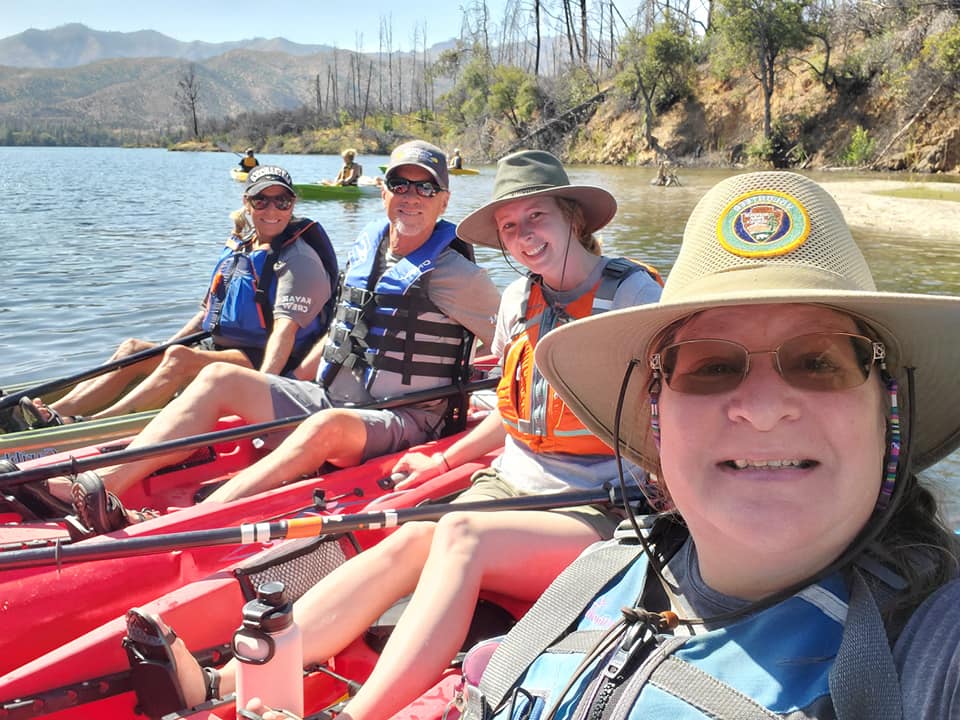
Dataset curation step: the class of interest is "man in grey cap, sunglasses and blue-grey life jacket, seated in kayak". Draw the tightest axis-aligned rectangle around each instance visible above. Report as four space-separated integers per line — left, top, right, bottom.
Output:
51 141 500 533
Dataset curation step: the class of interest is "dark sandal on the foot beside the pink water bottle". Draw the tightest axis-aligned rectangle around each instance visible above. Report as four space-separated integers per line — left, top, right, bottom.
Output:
123 608 220 718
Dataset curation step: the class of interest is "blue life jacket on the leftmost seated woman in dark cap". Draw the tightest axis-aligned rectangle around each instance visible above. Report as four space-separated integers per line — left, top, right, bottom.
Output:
203 218 338 355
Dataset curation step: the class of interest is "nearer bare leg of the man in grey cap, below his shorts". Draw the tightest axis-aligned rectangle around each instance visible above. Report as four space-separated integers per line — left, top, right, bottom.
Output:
207 409 367 502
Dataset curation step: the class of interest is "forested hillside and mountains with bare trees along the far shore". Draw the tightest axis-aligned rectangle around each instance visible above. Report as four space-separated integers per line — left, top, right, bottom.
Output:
0 0 960 172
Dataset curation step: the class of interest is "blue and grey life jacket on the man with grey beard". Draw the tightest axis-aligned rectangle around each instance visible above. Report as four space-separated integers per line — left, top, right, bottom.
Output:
318 220 472 396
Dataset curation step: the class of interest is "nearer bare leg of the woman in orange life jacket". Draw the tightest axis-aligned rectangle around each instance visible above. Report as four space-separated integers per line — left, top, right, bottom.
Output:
340 512 598 720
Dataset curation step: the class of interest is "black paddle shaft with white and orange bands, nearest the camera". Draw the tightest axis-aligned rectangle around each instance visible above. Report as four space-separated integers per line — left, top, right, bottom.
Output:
0 488 643 569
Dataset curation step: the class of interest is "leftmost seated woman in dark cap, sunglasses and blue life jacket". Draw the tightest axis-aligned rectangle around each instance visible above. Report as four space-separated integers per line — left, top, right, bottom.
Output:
21 165 339 427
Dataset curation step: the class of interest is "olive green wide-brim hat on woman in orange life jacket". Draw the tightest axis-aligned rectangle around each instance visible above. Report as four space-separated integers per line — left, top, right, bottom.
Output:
457 150 617 248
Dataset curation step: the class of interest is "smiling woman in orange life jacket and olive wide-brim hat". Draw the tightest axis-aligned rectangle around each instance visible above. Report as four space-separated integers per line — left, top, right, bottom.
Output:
116 151 660 720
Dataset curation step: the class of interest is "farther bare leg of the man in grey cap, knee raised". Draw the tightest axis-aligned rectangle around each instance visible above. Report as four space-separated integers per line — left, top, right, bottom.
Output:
51 363 274 494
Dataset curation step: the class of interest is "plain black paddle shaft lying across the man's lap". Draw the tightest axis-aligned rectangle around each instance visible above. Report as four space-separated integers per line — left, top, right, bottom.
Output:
0 378 499 490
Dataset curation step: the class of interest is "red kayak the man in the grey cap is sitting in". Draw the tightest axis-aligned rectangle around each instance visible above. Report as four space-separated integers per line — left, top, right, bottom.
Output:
0 394 506 668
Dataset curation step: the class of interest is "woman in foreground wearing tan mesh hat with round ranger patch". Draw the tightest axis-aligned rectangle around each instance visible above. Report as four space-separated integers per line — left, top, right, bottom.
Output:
460 172 960 720
